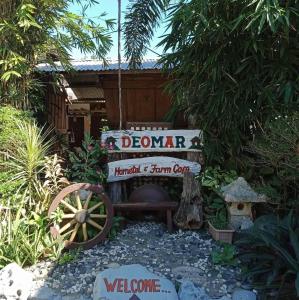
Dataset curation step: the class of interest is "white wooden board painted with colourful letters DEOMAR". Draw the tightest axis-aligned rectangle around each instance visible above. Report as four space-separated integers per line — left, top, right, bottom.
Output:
102 130 203 153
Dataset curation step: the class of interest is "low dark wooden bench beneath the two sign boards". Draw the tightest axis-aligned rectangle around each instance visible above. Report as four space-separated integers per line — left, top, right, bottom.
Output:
113 201 178 232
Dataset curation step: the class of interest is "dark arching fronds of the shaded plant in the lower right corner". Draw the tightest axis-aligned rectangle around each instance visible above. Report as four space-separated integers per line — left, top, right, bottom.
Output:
237 212 299 297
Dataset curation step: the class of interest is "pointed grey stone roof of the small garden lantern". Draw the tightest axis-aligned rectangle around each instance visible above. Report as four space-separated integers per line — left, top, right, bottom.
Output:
221 177 267 203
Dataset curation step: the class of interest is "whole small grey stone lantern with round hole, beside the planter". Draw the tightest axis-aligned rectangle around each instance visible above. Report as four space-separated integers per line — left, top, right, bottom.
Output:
221 177 267 230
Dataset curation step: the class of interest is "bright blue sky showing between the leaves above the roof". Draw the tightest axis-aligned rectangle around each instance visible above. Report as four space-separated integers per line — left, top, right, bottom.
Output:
70 0 169 59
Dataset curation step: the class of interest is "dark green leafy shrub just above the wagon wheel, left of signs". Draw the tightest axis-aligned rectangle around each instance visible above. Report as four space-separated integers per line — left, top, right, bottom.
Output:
69 134 107 183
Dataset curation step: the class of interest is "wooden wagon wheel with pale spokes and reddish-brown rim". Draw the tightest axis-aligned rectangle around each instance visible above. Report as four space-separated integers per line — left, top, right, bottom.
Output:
48 183 113 249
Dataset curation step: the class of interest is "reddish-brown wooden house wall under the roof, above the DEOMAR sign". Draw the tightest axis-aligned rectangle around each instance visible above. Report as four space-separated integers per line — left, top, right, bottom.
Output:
103 74 177 128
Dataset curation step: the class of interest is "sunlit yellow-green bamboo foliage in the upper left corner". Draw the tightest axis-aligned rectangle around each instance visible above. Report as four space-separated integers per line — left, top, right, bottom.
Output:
0 0 114 109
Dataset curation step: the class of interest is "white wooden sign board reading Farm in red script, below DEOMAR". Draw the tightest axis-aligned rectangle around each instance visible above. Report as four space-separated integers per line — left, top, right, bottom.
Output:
107 156 201 182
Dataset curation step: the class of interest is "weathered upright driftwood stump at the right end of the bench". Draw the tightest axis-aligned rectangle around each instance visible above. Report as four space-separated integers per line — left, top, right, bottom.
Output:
174 172 203 229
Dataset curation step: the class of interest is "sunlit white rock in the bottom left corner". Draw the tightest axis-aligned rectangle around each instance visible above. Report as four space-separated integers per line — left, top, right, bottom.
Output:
0 263 33 300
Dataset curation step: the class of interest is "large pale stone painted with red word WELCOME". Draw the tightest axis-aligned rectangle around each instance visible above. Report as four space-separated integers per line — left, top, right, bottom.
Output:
93 264 178 300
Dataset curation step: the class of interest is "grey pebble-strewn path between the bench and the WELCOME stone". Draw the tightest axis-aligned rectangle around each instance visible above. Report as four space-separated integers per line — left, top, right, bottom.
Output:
28 222 245 300
